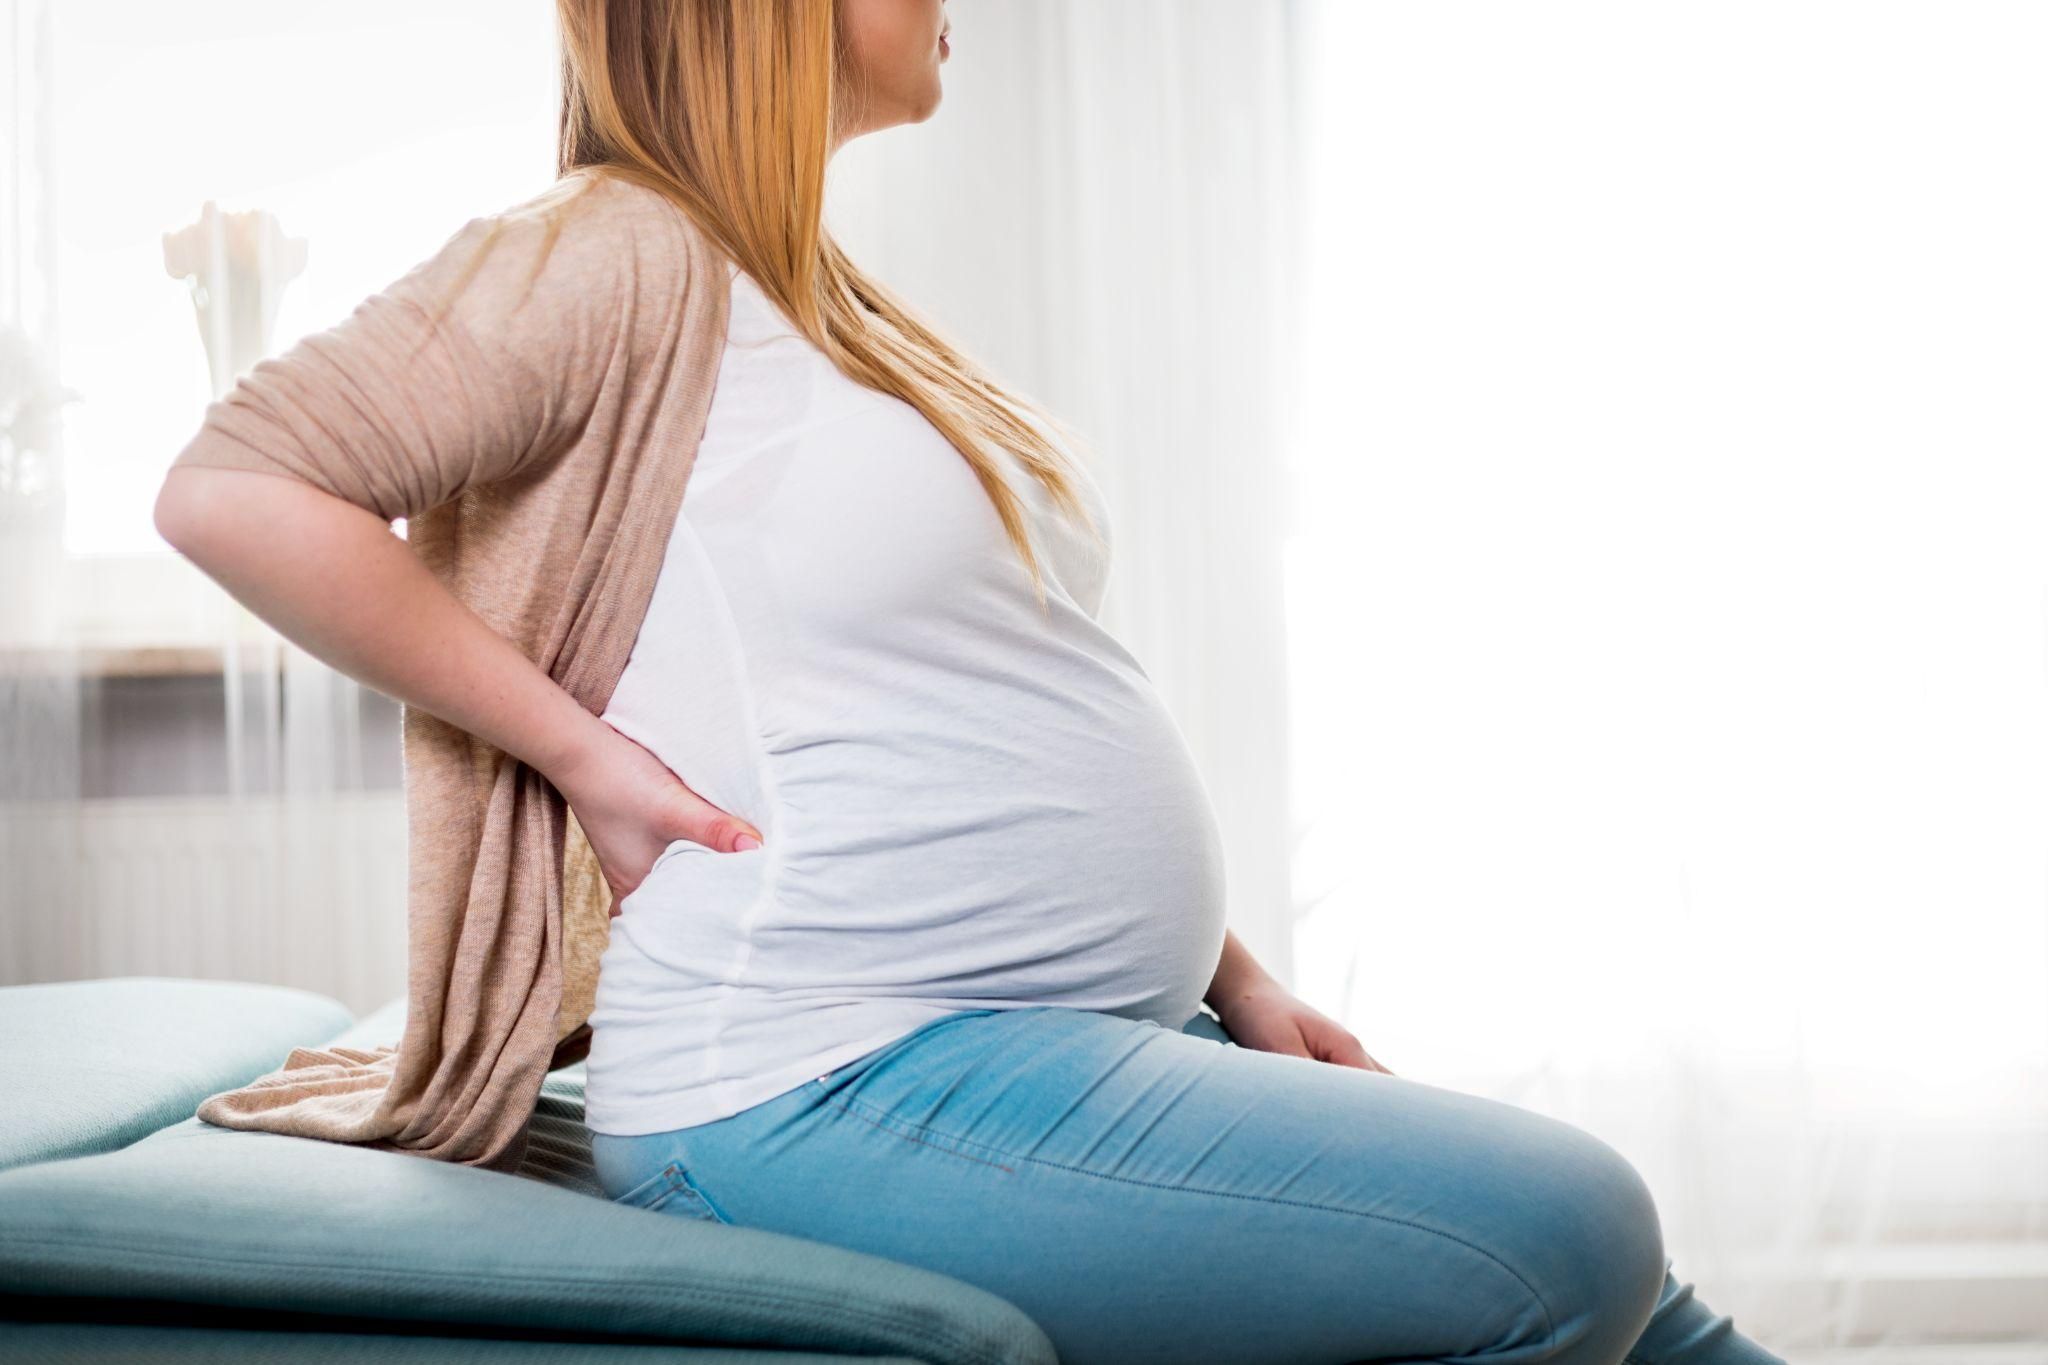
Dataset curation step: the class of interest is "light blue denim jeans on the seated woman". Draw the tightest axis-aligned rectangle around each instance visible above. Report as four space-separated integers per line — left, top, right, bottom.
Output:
592 1005 1784 1365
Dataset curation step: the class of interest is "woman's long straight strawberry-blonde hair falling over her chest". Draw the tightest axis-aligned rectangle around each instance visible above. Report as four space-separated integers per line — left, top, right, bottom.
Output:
528 0 1102 610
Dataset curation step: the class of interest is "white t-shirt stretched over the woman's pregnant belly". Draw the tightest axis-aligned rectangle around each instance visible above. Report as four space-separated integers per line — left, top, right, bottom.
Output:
586 266 1225 1136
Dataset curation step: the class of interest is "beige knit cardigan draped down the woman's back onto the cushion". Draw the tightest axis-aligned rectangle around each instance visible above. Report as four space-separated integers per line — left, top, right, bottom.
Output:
174 172 729 1171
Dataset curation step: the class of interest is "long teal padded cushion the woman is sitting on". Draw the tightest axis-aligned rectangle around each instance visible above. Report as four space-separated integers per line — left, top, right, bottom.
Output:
0 993 1055 1365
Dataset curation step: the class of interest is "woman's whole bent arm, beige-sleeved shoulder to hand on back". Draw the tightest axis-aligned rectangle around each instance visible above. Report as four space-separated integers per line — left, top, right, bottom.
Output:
156 184 760 913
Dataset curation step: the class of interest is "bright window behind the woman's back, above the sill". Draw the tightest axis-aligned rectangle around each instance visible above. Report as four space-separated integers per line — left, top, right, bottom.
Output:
33 0 559 557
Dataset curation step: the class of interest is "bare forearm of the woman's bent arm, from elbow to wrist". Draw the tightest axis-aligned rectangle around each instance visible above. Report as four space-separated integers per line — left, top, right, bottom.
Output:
156 469 602 786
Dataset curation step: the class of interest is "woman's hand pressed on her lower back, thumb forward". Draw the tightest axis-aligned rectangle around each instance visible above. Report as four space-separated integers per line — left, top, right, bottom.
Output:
547 712 762 917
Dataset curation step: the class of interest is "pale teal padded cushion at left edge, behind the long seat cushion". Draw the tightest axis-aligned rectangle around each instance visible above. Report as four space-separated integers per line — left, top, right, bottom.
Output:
0 976 352 1171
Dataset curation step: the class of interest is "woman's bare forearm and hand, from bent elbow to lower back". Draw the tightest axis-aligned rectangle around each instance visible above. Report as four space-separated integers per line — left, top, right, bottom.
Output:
156 467 760 898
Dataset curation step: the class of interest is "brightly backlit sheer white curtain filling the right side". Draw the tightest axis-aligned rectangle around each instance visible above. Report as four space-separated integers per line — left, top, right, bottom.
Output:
1288 0 2048 1365
